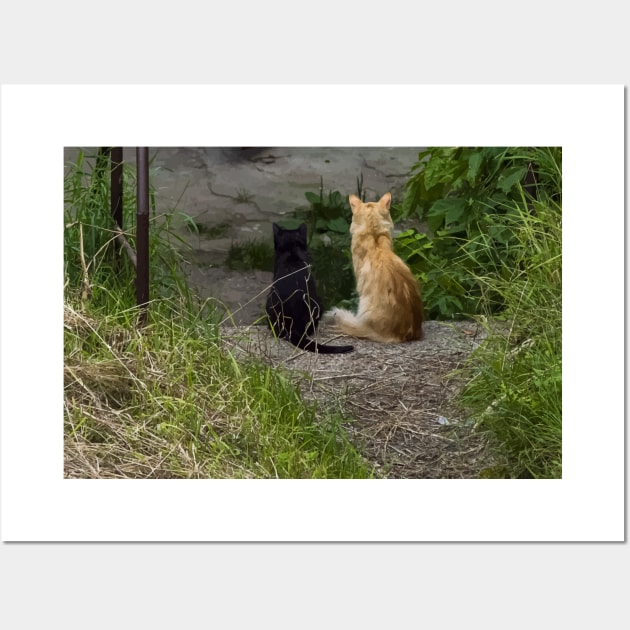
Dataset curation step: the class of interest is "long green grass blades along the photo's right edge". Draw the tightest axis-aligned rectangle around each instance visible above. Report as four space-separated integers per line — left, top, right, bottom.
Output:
460 193 562 478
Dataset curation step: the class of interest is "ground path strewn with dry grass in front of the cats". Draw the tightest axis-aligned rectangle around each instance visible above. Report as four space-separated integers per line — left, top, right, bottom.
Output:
223 322 504 479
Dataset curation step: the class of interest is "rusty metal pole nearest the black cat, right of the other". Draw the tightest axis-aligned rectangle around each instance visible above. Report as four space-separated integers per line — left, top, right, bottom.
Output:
136 147 149 324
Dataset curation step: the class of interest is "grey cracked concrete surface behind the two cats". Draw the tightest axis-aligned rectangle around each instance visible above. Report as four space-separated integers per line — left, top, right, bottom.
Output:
64 147 422 323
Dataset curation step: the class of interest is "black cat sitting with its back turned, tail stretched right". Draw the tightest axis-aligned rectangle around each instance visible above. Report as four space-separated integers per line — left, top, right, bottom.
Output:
266 223 354 354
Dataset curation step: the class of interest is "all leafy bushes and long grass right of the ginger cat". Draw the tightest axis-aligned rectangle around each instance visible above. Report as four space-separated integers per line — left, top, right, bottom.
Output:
395 147 562 478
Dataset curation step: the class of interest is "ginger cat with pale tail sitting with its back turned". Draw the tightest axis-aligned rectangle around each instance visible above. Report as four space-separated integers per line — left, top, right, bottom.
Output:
327 193 424 343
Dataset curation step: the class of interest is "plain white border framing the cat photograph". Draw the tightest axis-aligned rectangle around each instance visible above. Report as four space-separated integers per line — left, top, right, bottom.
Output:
0 85 624 541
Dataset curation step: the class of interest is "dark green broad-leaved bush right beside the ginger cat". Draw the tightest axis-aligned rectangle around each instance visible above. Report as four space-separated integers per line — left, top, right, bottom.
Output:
395 147 562 319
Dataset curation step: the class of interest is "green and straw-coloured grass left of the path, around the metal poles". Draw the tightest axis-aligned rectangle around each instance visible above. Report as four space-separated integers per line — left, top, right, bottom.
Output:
64 148 372 478
